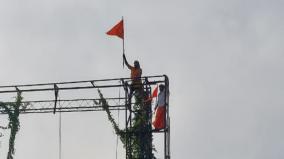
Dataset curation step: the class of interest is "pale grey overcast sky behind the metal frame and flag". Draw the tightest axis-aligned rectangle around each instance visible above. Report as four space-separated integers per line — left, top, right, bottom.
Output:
0 0 284 159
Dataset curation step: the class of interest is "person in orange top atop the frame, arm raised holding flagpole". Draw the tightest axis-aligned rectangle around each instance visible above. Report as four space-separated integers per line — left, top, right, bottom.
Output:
123 54 142 103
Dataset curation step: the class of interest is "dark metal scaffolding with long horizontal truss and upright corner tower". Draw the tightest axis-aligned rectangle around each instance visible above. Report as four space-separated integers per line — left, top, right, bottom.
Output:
0 75 170 159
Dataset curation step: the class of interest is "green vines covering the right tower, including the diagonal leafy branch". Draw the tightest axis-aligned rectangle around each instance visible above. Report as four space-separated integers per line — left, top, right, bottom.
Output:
95 90 155 159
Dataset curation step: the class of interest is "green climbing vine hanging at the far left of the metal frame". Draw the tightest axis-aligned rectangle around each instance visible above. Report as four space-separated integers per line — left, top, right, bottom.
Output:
0 93 22 159
